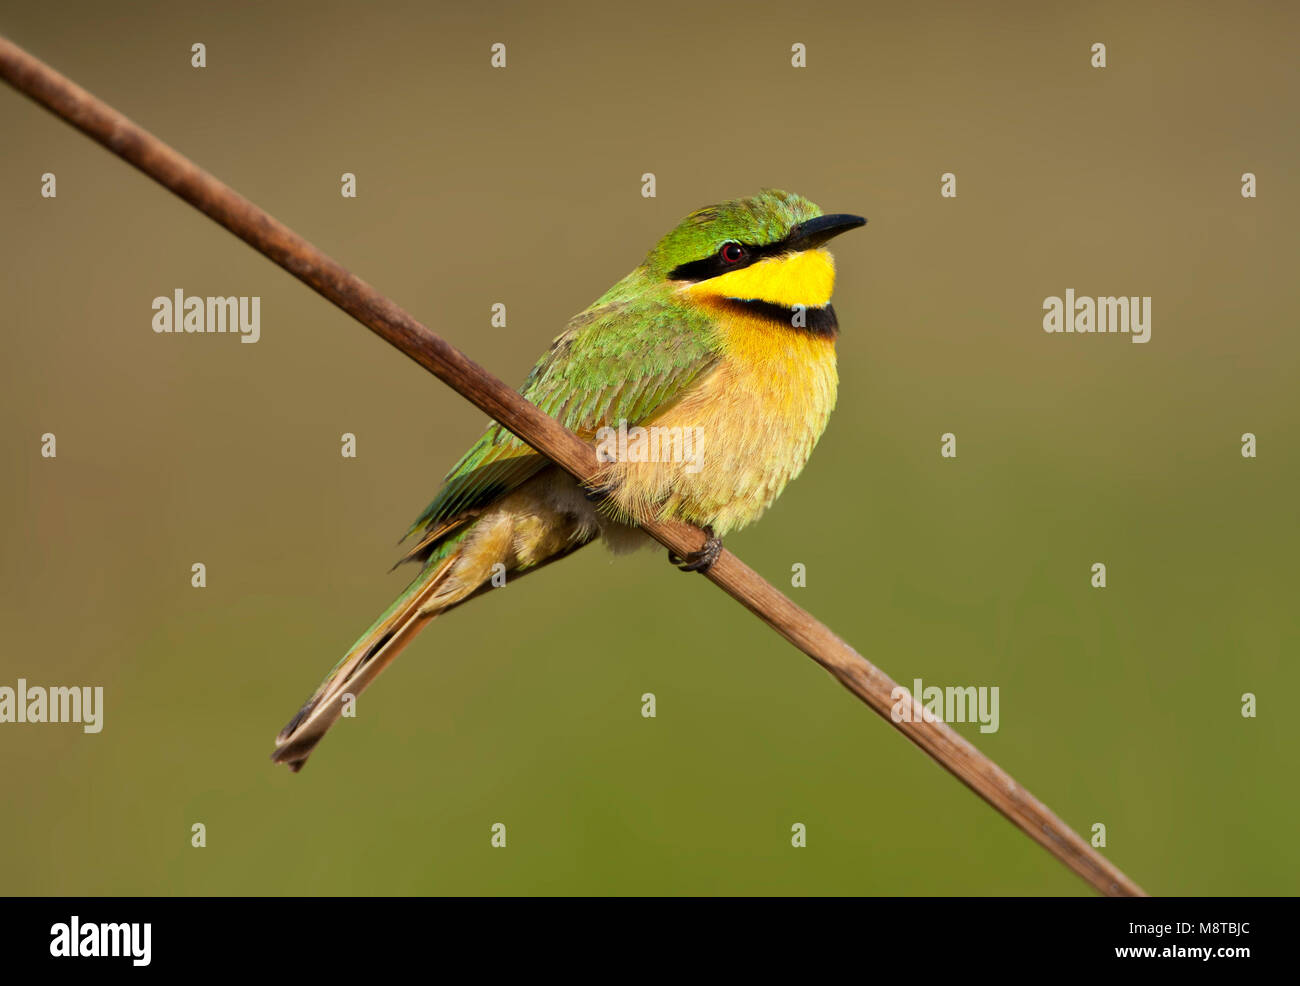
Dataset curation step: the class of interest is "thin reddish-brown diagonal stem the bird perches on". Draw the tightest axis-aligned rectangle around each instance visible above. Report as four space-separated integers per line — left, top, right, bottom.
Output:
0 38 1143 896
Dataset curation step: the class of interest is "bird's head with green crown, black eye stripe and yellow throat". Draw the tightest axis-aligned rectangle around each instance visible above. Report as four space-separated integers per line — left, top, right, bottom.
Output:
645 189 866 308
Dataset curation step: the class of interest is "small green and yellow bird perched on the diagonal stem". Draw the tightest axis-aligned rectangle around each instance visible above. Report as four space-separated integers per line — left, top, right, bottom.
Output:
272 190 866 771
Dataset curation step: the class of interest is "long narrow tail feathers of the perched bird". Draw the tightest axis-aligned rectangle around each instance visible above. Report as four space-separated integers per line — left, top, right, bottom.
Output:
270 553 460 773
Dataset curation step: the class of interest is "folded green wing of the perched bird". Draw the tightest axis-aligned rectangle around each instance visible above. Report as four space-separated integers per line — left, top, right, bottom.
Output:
407 289 718 554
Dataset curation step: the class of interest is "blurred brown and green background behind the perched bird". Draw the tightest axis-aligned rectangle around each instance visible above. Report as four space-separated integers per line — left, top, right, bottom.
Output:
0 1 1300 895
